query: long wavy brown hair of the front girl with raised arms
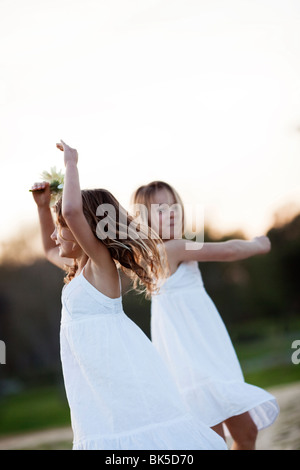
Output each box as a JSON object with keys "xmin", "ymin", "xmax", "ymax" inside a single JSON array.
[{"xmin": 54, "ymin": 189, "xmax": 167, "ymax": 297}]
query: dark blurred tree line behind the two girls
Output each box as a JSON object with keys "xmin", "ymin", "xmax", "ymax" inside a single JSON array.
[{"xmin": 0, "ymin": 214, "xmax": 300, "ymax": 395}]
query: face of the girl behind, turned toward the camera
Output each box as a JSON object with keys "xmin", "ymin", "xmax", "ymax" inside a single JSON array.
[{"xmin": 149, "ymin": 189, "xmax": 182, "ymax": 240}]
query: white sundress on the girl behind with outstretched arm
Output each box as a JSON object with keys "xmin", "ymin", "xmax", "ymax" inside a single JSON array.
[{"xmin": 151, "ymin": 261, "xmax": 279, "ymax": 433}]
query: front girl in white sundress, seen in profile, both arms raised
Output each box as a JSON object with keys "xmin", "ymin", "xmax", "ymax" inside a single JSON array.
[{"xmin": 32, "ymin": 142, "xmax": 226, "ymax": 450}]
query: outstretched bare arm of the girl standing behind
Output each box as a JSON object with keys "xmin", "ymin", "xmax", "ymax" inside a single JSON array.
[{"xmin": 165, "ymin": 236, "xmax": 271, "ymax": 265}]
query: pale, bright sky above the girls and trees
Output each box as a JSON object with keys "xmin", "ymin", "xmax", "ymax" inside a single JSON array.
[{"xmin": 0, "ymin": 0, "xmax": 300, "ymax": 252}]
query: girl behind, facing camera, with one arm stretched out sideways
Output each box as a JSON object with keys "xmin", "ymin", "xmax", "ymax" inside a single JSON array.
[{"xmin": 133, "ymin": 181, "xmax": 279, "ymax": 449}]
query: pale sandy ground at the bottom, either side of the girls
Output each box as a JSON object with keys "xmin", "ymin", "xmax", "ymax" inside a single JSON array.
[{"xmin": 0, "ymin": 382, "xmax": 300, "ymax": 450}]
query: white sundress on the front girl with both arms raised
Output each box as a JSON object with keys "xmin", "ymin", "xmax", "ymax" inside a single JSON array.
[{"xmin": 60, "ymin": 271, "xmax": 227, "ymax": 450}]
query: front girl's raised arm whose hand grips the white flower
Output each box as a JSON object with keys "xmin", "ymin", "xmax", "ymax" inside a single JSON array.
[{"xmin": 31, "ymin": 182, "xmax": 71, "ymax": 269}]
